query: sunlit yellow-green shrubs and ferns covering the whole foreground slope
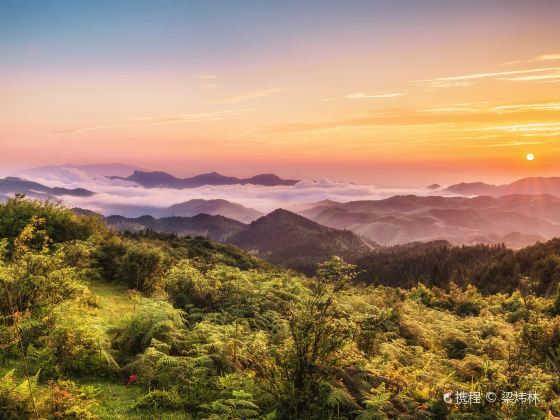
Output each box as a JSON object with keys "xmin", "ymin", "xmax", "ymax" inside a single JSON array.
[{"xmin": 0, "ymin": 197, "xmax": 560, "ymax": 420}]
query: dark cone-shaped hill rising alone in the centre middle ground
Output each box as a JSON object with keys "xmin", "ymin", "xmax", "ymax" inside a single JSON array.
[{"xmin": 228, "ymin": 209, "xmax": 377, "ymax": 273}]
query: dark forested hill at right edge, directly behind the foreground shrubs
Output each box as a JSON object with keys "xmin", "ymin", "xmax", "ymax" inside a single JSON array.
[{"xmin": 356, "ymin": 238, "xmax": 560, "ymax": 295}]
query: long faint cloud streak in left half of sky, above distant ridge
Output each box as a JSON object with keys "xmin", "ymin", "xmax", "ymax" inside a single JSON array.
[{"xmin": 55, "ymin": 109, "xmax": 246, "ymax": 134}]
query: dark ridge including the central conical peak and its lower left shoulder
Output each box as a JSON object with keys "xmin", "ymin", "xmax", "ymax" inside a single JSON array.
[{"xmin": 103, "ymin": 209, "xmax": 379, "ymax": 273}]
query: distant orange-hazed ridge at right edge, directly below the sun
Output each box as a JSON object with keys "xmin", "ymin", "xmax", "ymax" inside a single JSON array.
[{"xmin": 444, "ymin": 177, "xmax": 560, "ymax": 197}]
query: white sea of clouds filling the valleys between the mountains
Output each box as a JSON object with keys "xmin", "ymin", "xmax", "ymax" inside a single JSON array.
[{"xmin": 19, "ymin": 167, "xmax": 440, "ymax": 217}]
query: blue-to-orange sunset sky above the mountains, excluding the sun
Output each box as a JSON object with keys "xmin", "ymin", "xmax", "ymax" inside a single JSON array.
[{"xmin": 0, "ymin": 0, "xmax": 560, "ymax": 186}]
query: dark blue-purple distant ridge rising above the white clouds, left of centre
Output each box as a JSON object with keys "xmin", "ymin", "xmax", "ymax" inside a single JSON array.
[{"xmin": 109, "ymin": 170, "xmax": 299, "ymax": 189}]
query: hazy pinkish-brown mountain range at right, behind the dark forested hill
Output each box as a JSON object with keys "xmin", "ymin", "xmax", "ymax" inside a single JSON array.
[{"xmin": 299, "ymin": 194, "xmax": 560, "ymax": 248}]
